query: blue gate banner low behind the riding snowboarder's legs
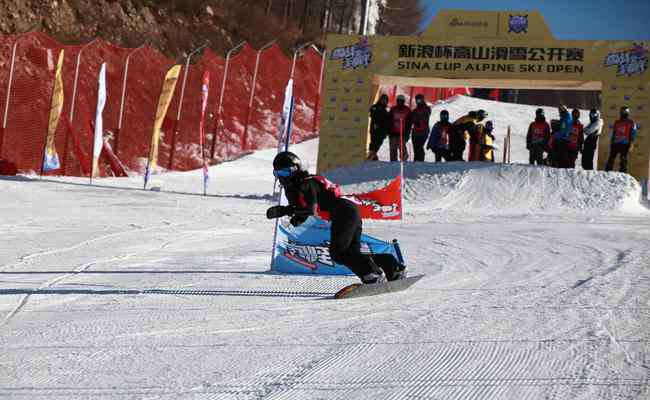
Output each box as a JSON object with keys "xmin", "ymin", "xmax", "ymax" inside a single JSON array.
[{"xmin": 271, "ymin": 217, "xmax": 397, "ymax": 275}]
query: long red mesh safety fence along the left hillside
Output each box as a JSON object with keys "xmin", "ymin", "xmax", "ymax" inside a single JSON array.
[{"xmin": 0, "ymin": 32, "xmax": 323, "ymax": 176}]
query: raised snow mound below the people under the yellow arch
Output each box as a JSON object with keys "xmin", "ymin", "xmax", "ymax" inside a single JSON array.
[{"xmin": 328, "ymin": 162, "xmax": 647, "ymax": 213}]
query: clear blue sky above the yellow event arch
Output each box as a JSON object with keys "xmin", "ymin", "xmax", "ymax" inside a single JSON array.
[{"xmin": 420, "ymin": 0, "xmax": 650, "ymax": 40}]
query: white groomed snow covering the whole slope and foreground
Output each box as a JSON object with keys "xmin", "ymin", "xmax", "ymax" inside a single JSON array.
[{"xmin": 0, "ymin": 99, "xmax": 650, "ymax": 400}]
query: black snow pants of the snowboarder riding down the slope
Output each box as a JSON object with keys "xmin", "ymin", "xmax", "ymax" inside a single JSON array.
[{"xmin": 330, "ymin": 199, "xmax": 399, "ymax": 279}]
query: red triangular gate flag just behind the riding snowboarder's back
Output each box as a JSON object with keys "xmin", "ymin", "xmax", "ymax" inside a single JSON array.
[{"xmin": 318, "ymin": 175, "xmax": 402, "ymax": 220}]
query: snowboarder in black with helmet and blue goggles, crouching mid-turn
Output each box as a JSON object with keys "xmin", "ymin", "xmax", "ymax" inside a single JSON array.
[{"xmin": 266, "ymin": 151, "xmax": 406, "ymax": 283}]
